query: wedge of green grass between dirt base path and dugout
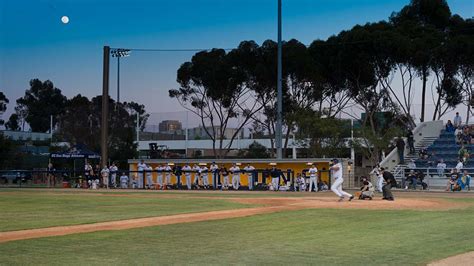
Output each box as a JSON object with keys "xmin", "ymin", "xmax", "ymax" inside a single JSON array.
[{"xmin": 0, "ymin": 193, "xmax": 255, "ymax": 231}]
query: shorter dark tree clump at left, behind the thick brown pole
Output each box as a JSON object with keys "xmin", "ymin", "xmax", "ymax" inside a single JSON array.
[{"xmin": 0, "ymin": 79, "xmax": 149, "ymax": 167}]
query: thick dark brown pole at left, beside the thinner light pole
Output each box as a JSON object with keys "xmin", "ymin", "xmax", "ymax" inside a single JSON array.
[{"xmin": 100, "ymin": 46, "xmax": 110, "ymax": 166}]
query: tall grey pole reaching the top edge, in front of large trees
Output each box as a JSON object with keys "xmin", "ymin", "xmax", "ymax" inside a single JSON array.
[{"xmin": 275, "ymin": 0, "xmax": 283, "ymax": 160}]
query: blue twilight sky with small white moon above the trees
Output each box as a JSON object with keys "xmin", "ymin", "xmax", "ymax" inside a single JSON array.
[{"xmin": 0, "ymin": 0, "xmax": 474, "ymax": 122}]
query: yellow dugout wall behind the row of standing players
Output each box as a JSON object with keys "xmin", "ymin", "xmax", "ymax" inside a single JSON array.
[{"xmin": 128, "ymin": 158, "xmax": 348, "ymax": 189}]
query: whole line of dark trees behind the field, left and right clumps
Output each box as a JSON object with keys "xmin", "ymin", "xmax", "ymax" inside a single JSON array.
[{"xmin": 0, "ymin": 0, "xmax": 474, "ymax": 165}]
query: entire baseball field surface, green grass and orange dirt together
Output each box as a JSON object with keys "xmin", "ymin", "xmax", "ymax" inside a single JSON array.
[{"xmin": 0, "ymin": 189, "xmax": 474, "ymax": 265}]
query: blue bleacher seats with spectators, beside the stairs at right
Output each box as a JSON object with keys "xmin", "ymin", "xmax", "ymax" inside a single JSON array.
[{"xmin": 415, "ymin": 129, "xmax": 474, "ymax": 169}]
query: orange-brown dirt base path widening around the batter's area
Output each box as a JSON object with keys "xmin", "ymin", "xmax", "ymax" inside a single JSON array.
[{"xmin": 0, "ymin": 192, "xmax": 468, "ymax": 243}]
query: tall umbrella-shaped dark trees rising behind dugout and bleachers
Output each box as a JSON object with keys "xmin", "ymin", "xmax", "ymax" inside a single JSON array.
[{"xmin": 169, "ymin": 0, "xmax": 474, "ymax": 161}]
